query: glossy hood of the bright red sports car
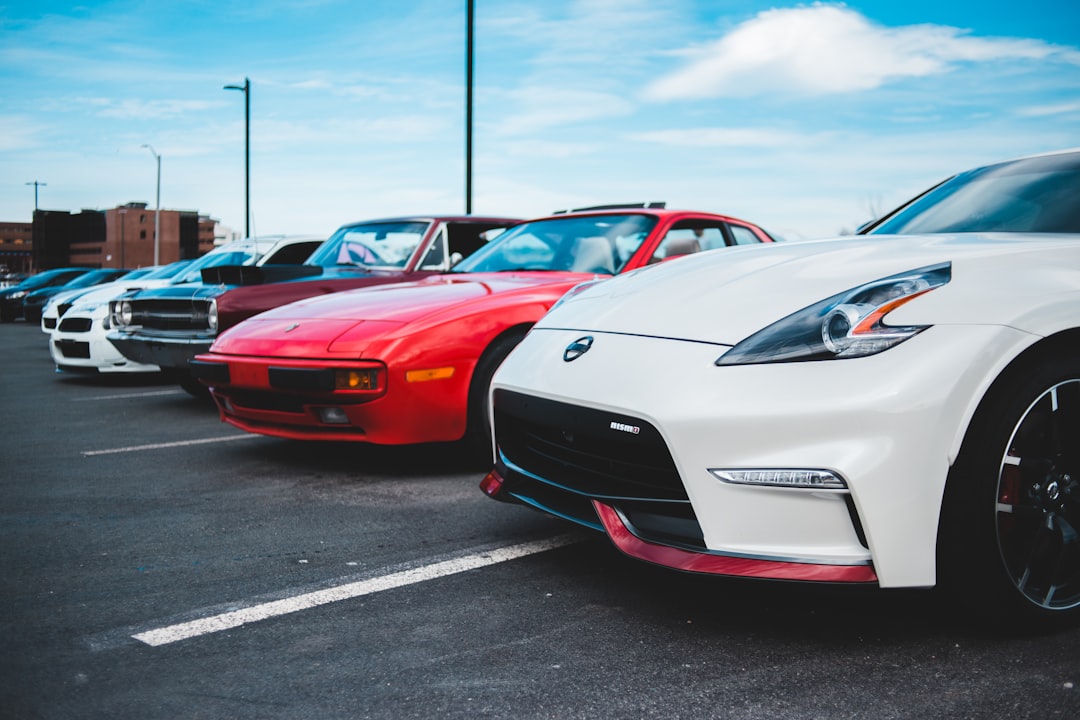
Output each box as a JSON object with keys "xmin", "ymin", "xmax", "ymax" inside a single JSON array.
[{"xmin": 211, "ymin": 272, "xmax": 594, "ymax": 358}]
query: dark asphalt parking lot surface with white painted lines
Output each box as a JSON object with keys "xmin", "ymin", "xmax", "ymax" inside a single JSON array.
[{"xmin": 0, "ymin": 323, "xmax": 1080, "ymax": 720}]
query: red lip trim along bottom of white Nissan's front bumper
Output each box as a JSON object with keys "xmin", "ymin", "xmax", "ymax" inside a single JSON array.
[{"xmin": 593, "ymin": 500, "xmax": 877, "ymax": 583}]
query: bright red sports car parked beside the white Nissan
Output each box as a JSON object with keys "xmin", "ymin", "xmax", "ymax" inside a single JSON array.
[{"xmin": 191, "ymin": 204, "xmax": 772, "ymax": 457}]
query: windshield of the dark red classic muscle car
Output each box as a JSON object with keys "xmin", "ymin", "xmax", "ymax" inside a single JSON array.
[{"xmin": 305, "ymin": 220, "xmax": 431, "ymax": 269}]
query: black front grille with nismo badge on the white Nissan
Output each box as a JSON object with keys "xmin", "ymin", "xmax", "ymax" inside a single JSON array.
[{"xmin": 494, "ymin": 390, "xmax": 689, "ymax": 501}]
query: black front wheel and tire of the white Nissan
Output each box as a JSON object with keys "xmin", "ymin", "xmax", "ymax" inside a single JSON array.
[{"xmin": 939, "ymin": 340, "xmax": 1080, "ymax": 626}]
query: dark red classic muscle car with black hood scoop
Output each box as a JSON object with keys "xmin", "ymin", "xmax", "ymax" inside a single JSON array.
[{"xmin": 110, "ymin": 215, "xmax": 519, "ymax": 396}]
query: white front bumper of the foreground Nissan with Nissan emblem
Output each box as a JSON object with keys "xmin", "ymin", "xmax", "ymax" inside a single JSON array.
[{"xmin": 487, "ymin": 326, "xmax": 1034, "ymax": 586}]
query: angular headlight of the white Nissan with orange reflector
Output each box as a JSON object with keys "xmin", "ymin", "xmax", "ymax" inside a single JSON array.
[{"xmin": 716, "ymin": 262, "xmax": 953, "ymax": 365}]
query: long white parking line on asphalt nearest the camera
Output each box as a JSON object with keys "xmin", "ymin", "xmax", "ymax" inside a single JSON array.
[{"xmin": 132, "ymin": 535, "xmax": 581, "ymax": 647}]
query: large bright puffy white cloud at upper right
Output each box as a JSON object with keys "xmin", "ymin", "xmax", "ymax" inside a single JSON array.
[{"xmin": 645, "ymin": 3, "xmax": 1080, "ymax": 100}]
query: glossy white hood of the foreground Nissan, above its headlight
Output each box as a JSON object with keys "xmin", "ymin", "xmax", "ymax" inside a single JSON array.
[{"xmin": 537, "ymin": 233, "xmax": 1080, "ymax": 344}]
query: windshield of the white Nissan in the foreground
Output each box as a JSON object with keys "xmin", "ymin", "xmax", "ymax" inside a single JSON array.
[{"xmin": 868, "ymin": 153, "xmax": 1080, "ymax": 234}]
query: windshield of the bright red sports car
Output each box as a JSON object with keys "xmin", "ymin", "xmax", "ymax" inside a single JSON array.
[{"xmin": 453, "ymin": 214, "xmax": 657, "ymax": 275}]
